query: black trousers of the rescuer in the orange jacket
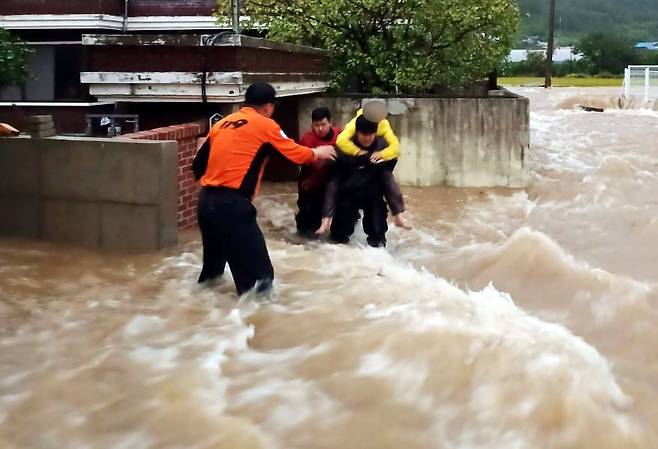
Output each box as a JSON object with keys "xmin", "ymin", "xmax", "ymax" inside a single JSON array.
[{"xmin": 197, "ymin": 187, "xmax": 274, "ymax": 295}]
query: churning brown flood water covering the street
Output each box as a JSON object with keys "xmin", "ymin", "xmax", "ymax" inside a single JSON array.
[{"xmin": 0, "ymin": 88, "xmax": 658, "ymax": 449}]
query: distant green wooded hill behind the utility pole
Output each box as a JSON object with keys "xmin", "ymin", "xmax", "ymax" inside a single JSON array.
[{"xmin": 519, "ymin": 0, "xmax": 658, "ymax": 44}]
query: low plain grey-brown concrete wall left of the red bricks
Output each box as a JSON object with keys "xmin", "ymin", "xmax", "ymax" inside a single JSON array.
[{"xmin": 0, "ymin": 137, "xmax": 178, "ymax": 251}]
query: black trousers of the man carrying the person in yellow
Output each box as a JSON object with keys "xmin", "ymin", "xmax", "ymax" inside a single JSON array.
[{"xmin": 331, "ymin": 194, "xmax": 388, "ymax": 248}]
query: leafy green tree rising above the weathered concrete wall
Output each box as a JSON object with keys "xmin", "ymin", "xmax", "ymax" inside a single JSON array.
[{"xmin": 220, "ymin": 0, "xmax": 518, "ymax": 93}]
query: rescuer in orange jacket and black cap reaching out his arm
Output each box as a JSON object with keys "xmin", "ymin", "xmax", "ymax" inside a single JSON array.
[{"xmin": 192, "ymin": 83, "xmax": 336, "ymax": 295}]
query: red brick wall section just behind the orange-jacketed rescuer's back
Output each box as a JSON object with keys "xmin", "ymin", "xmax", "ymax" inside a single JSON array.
[{"xmin": 122, "ymin": 123, "xmax": 202, "ymax": 230}]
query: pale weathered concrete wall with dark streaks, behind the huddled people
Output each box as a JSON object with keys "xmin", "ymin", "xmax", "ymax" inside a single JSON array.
[{"xmin": 299, "ymin": 91, "xmax": 530, "ymax": 187}]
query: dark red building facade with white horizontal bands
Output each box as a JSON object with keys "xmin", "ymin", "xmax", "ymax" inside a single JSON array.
[{"xmin": 0, "ymin": 0, "xmax": 328, "ymax": 136}]
